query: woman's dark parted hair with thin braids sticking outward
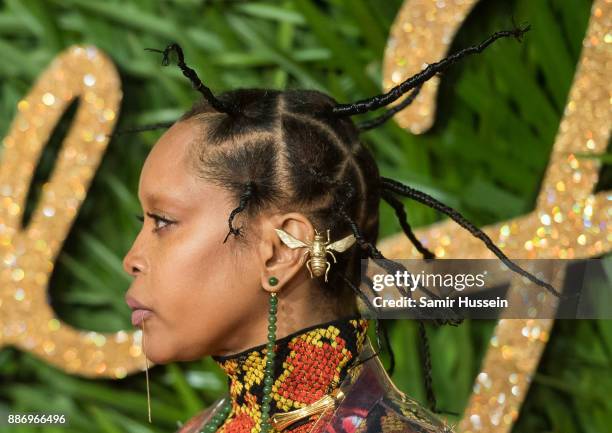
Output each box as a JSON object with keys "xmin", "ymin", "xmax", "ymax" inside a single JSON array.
[{"xmin": 113, "ymin": 25, "xmax": 560, "ymax": 413}]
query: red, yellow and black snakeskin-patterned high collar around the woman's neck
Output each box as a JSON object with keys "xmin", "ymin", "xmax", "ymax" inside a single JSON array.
[{"xmin": 212, "ymin": 315, "xmax": 368, "ymax": 432}]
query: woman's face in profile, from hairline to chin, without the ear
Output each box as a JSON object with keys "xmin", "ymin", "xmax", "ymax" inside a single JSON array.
[{"xmin": 123, "ymin": 120, "xmax": 267, "ymax": 363}]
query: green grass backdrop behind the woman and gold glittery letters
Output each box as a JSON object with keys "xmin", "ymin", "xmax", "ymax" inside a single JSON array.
[{"xmin": 0, "ymin": 0, "xmax": 612, "ymax": 433}]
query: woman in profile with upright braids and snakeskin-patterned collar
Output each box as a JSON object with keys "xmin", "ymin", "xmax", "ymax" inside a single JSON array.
[{"xmin": 124, "ymin": 24, "xmax": 560, "ymax": 433}]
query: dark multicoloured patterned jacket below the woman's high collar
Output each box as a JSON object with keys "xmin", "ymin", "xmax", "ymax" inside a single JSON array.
[{"xmin": 176, "ymin": 338, "xmax": 454, "ymax": 433}]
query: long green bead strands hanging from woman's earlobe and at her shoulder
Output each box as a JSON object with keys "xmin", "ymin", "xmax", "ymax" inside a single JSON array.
[{"xmin": 200, "ymin": 284, "xmax": 278, "ymax": 433}]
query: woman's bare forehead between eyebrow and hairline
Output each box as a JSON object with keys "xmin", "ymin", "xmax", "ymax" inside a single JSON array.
[{"xmin": 138, "ymin": 122, "xmax": 199, "ymax": 205}]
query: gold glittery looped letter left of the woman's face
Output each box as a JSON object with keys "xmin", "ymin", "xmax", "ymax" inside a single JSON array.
[{"xmin": 0, "ymin": 46, "xmax": 144, "ymax": 378}]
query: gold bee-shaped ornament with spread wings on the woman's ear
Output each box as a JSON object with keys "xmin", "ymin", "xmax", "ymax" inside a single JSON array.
[{"xmin": 274, "ymin": 229, "xmax": 356, "ymax": 282}]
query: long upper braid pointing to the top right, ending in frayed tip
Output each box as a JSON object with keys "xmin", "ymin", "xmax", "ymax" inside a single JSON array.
[{"xmin": 332, "ymin": 25, "xmax": 530, "ymax": 116}]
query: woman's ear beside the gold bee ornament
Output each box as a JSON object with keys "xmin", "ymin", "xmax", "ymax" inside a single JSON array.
[{"xmin": 258, "ymin": 212, "xmax": 314, "ymax": 292}]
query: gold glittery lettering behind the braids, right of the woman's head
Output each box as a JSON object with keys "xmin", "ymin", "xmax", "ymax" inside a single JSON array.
[{"xmin": 380, "ymin": 0, "xmax": 612, "ymax": 433}]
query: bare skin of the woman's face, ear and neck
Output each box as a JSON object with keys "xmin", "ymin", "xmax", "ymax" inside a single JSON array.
[{"xmin": 123, "ymin": 119, "xmax": 339, "ymax": 364}]
